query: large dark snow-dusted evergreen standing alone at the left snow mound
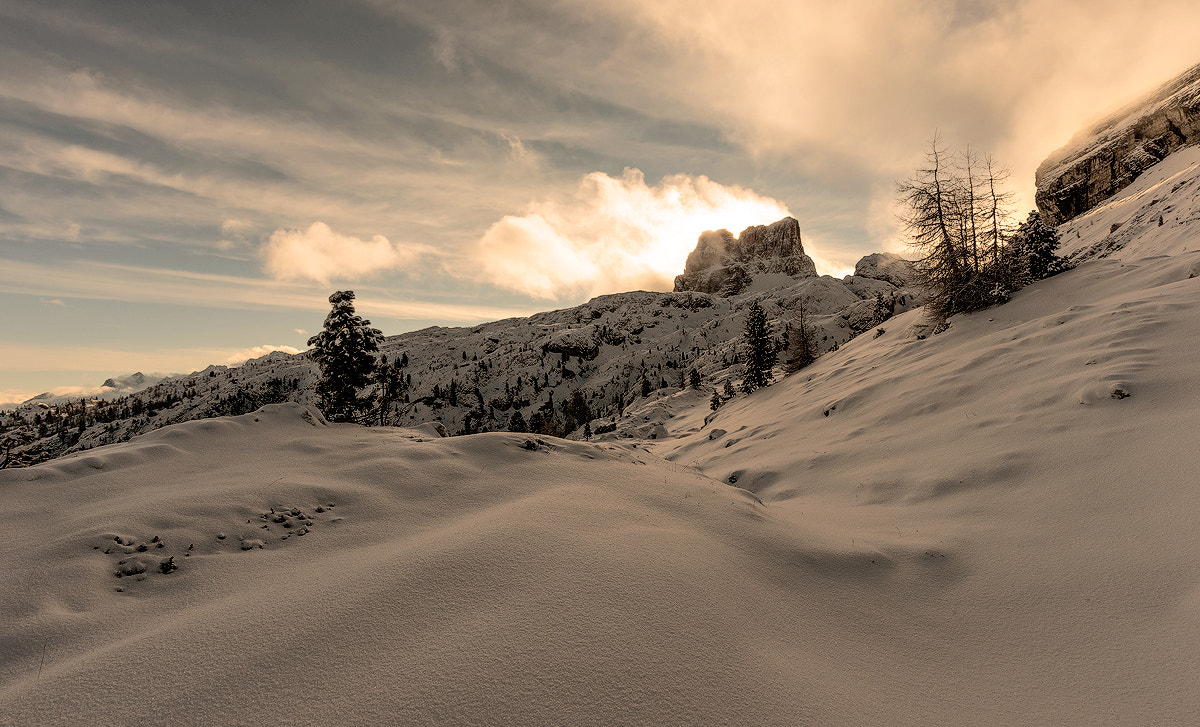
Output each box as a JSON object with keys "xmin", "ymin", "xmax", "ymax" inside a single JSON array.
[{"xmin": 308, "ymin": 290, "xmax": 383, "ymax": 421}]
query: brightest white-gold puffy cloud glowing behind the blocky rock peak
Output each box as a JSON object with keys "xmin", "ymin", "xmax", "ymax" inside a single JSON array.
[{"xmin": 474, "ymin": 168, "xmax": 790, "ymax": 299}]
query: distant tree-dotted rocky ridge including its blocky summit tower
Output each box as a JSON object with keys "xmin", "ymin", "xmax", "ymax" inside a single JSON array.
[{"xmin": 0, "ymin": 218, "xmax": 923, "ymax": 464}]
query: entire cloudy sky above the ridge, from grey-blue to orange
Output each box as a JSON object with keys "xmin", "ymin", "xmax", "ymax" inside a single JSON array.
[{"xmin": 0, "ymin": 0, "xmax": 1200, "ymax": 401}]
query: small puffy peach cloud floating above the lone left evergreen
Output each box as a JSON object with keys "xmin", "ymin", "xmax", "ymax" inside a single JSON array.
[{"xmin": 262, "ymin": 222, "xmax": 430, "ymax": 283}]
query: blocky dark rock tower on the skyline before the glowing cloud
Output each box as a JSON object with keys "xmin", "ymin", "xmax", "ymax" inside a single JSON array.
[{"xmin": 674, "ymin": 217, "xmax": 817, "ymax": 296}]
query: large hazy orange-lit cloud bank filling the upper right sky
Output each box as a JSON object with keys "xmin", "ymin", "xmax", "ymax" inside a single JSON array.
[{"xmin": 608, "ymin": 0, "xmax": 1200, "ymax": 230}]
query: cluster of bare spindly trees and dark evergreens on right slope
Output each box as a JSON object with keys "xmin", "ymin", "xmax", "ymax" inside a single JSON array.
[{"xmin": 896, "ymin": 138, "xmax": 1066, "ymax": 323}]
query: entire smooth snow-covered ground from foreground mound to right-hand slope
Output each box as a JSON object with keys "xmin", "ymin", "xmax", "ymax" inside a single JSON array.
[{"xmin": 0, "ymin": 146, "xmax": 1200, "ymax": 725}]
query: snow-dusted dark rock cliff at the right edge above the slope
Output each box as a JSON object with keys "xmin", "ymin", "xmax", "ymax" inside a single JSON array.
[{"xmin": 1036, "ymin": 65, "xmax": 1200, "ymax": 224}]
